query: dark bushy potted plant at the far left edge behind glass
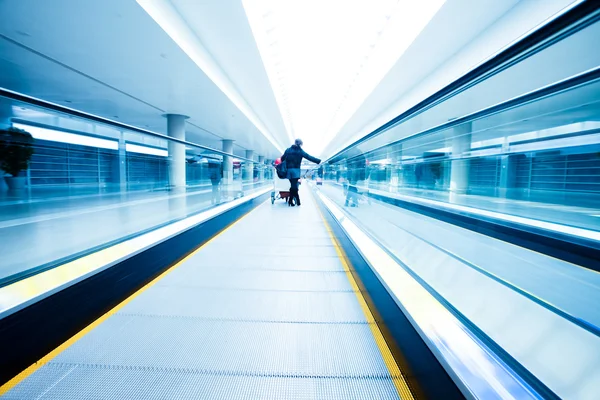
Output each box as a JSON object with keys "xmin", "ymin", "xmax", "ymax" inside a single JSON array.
[{"xmin": 0, "ymin": 127, "xmax": 33, "ymax": 189}]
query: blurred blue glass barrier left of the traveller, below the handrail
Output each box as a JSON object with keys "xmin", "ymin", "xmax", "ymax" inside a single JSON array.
[{"xmin": 0, "ymin": 97, "xmax": 272, "ymax": 285}]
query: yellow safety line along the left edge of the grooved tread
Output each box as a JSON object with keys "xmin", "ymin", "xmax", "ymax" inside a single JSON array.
[{"xmin": 0, "ymin": 208, "xmax": 255, "ymax": 396}]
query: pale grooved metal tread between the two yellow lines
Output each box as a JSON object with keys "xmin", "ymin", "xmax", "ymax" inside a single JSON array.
[{"xmin": 5, "ymin": 190, "xmax": 398, "ymax": 400}]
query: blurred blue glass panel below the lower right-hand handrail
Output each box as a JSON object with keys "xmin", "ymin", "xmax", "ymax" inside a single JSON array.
[{"xmin": 323, "ymin": 68, "xmax": 600, "ymax": 231}]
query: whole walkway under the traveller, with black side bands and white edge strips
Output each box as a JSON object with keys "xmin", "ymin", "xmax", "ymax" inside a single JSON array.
[{"xmin": 0, "ymin": 188, "xmax": 576, "ymax": 399}]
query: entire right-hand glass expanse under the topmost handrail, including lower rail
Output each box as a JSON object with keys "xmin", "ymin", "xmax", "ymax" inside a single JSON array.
[{"xmin": 321, "ymin": 6, "xmax": 600, "ymax": 236}]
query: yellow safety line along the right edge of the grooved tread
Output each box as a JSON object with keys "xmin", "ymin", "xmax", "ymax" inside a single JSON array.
[{"xmin": 315, "ymin": 196, "xmax": 415, "ymax": 400}]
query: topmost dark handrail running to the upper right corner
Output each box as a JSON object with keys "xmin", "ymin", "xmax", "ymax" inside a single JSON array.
[{"xmin": 324, "ymin": 1, "xmax": 600, "ymax": 164}]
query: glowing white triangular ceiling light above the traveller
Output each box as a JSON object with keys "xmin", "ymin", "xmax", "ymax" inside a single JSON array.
[{"xmin": 243, "ymin": 0, "xmax": 445, "ymax": 155}]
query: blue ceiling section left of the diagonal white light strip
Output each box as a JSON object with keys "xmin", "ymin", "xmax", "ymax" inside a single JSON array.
[{"xmin": 0, "ymin": 0, "xmax": 288, "ymax": 158}]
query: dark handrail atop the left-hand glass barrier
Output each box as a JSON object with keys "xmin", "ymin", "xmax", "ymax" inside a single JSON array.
[{"xmin": 0, "ymin": 87, "xmax": 258, "ymax": 163}]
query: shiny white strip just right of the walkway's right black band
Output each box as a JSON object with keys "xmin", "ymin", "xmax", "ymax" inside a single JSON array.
[{"xmin": 317, "ymin": 191, "xmax": 540, "ymax": 399}]
